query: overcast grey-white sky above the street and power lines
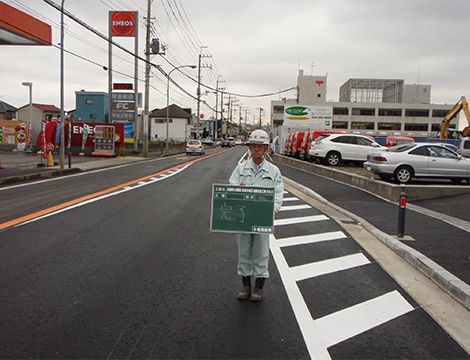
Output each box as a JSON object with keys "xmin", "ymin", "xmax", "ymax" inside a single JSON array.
[{"xmin": 0, "ymin": 0, "xmax": 470, "ymax": 124}]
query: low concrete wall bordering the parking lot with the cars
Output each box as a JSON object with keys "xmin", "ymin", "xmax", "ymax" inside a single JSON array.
[{"xmin": 270, "ymin": 154, "xmax": 470, "ymax": 202}]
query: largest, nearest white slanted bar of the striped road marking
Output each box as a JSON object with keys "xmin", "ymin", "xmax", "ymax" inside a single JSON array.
[{"xmin": 318, "ymin": 290, "xmax": 414, "ymax": 348}]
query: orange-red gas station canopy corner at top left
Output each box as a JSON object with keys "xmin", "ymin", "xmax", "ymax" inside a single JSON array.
[{"xmin": 0, "ymin": 1, "xmax": 52, "ymax": 45}]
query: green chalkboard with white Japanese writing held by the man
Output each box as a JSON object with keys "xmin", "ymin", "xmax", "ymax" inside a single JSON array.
[{"xmin": 211, "ymin": 184, "xmax": 275, "ymax": 234}]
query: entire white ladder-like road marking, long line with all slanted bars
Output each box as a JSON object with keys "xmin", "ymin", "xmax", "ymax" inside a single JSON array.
[{"xmin": 270, "ymin": 190, "xmax": 413, "ymax": 359}]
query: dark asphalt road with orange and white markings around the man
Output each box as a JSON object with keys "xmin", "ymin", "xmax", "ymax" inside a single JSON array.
[{"xmin": 0, "ymin": 148, "xmax": 470, "ymax": 359}]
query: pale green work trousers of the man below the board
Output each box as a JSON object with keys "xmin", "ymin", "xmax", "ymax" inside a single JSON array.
[{"xmin": 236, "ymin": 233, "xmax": 269, "ymax": 278}]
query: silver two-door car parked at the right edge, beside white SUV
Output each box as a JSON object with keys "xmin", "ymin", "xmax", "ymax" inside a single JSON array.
[{"xmin": 364, "ymin": 143, "xmax": 470, "ymax": 184}]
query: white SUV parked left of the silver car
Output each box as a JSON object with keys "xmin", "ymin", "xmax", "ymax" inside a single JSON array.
[{"xmin": 309, "ymin": 134, "xmax": 381, "ymax": 166}]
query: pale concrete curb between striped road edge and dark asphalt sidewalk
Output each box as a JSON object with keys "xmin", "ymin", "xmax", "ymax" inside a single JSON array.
[{"xmin": 283, "ymin": 177, "xmax": 470, "ymax": 310}]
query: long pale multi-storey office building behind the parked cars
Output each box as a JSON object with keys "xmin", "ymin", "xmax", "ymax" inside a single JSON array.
[{"xmin": 271, "ymin": 70, "xmax": 458, "ymax": 138}]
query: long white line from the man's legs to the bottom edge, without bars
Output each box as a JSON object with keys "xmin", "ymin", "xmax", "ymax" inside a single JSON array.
[{"xmin": 269, "ymin": 235, "xmax": 331, "ymax": 360}]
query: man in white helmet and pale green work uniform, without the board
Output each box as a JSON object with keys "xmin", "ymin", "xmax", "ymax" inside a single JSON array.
[{"xmin": 229, "ymin": 130, "xmax": 284, "ymax": 301}]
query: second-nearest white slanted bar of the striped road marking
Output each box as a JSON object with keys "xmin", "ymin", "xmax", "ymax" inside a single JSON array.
[{"xmin": 290, "ymin": 253, "xmax": 370, "ymax": 281}]
